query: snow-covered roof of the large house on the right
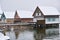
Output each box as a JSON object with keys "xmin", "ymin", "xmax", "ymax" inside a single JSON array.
[{"xmin": 32, "ymin": 6, "xmax": 59, "ymax": 15}]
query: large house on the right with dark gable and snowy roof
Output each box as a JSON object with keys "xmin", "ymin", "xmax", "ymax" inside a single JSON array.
[{"xmin": 33, "ymin": 6, "xmax": 59, "ymax": 28}]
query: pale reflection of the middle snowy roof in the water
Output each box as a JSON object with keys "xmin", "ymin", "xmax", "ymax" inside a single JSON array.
[{"xmin": 17, "ymin": 30, "xmax": 34, "ymax": 40}]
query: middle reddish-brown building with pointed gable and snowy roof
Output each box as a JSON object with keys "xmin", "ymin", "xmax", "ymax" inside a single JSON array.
[{"xmin": 14, "ymin": 10, "xmax": 33, "ymax": 23}]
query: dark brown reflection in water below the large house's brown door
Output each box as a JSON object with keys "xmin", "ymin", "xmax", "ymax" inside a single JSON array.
[{"xmin": 34, "ymin": 28, "xmax": 45, "ymax": 40}]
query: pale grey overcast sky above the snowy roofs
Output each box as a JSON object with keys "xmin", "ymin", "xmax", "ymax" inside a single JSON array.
[{"xmin": 0, "ymin": 0, "xmax": 60, "ymax": 11}]
